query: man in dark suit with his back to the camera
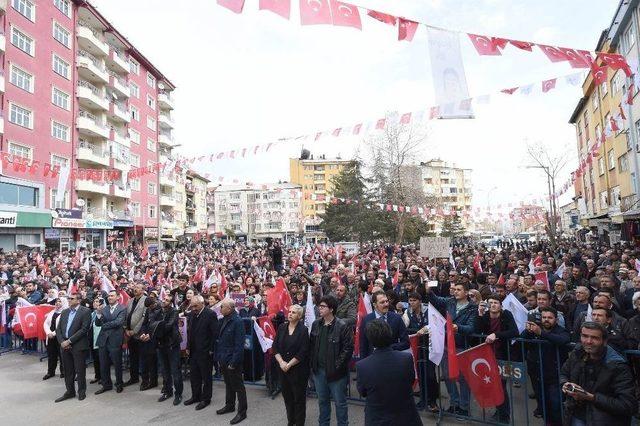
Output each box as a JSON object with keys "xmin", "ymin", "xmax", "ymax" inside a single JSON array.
[{"xmin": 356, "ymin": 319, "xmax": 422, "ymax": 426}]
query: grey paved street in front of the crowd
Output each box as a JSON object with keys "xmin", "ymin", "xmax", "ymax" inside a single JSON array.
[{"xmin": 0, "ymin": 353, "xmax": 450, "ymax": 426}]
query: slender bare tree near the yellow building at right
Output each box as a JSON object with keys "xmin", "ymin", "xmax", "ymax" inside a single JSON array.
[{"xmin": 527, "ymin": 142, "xmax": 569, "ymax": 246}]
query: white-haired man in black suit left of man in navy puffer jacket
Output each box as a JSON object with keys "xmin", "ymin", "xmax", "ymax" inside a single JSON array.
[{"xmin": 184, "ymin": 295, "xmax": 218, "ymax": 410}]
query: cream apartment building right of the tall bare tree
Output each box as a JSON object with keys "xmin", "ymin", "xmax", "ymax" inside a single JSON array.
[{"xmin": 419, "ymin": 159, "xmax": 473, "ymax": 232}]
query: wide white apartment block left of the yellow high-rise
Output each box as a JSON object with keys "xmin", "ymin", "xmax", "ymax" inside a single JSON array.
[{"xmin": 209, "ymin": 183, "xmax": 302, "ymax": 241}]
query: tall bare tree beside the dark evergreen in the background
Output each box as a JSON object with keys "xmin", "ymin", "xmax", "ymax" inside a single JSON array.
[{"xmin": 365, "ymin": 113, "xmax": 428, "ymax": 242}]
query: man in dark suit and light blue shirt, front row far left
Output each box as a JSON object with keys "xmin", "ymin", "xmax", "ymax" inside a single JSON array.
[{"xmin": 56, "ymin": 294, "xmax": 91, "ymax": 402}]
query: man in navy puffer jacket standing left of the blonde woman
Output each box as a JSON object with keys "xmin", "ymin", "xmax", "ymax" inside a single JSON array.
[{"xmin": 216, "ymin": 299, "xmax": 247, "ymax": 425}]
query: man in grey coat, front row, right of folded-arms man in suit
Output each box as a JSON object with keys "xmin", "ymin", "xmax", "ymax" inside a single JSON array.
[{"xmin": 124, "ymin": 282, "xmax": 149, "ymax": 390}]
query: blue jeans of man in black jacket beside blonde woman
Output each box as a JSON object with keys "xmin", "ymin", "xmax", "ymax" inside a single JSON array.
[{"xmin": 313, "ymin": 368, "xmax": 349, "ymax": 426}]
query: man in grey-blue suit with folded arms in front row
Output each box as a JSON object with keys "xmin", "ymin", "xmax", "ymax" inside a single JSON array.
[{"xmin": 96, "ymin": 290, "xmax": 127, "ymax": 395}]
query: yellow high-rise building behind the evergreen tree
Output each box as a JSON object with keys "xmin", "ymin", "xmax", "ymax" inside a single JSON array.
[{"xmin": 289, "ymin": 152, "xmax": 351, "ymax": 240}]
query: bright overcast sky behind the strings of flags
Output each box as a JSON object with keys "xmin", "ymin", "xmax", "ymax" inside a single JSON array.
[{"xmin": 92, "ymin": 0, "xmax": 618, "ymax": 213}]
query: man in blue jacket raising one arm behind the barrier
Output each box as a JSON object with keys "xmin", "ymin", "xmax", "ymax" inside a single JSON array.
[{"xmin": 426, "ymin": 282, "xmax": 478, "ymax": 416}]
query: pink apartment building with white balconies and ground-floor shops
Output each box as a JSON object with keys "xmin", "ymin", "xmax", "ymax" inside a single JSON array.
[{"xmin": 0, "ymin": 0, "xmax": 175, "ymax": 250}]
